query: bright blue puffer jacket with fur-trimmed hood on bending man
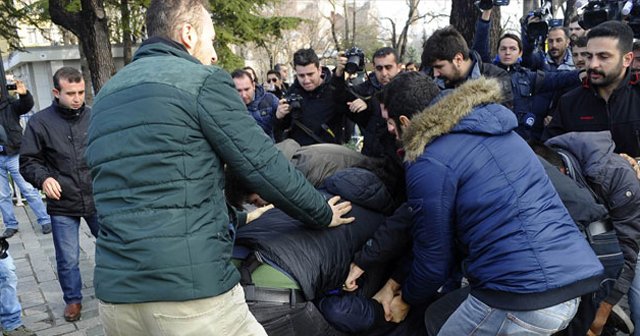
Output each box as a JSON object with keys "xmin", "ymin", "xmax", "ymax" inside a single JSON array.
[{"xmin": 403, "ymin": 78, "xmax": 603, "ymax": 310}]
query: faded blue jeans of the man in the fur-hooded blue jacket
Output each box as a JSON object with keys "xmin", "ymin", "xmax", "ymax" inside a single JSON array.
[{"xmin": 438, "ymin": 295, "xmax": 580, "ymax": 336}]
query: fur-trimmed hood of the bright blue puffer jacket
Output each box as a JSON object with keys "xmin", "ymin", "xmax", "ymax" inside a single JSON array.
[{"xmin": 402, "ymin": 77, "xmax": 518, "ymax": 162}]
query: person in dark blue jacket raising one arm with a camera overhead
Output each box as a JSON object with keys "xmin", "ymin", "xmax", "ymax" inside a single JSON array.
[{"xmin": 473, "ymin": 9, "xmax": 580, "ymax": 140}]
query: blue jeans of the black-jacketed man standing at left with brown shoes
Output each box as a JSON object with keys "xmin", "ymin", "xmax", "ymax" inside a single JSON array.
[{"xmin": 51, "ymin": 214, "xmax": 99, "ymax": 304}]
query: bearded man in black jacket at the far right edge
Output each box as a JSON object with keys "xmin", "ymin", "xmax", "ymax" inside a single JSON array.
[{"xmin": 544, "ymin": 21, "xmax": 640, "ymax": 157}]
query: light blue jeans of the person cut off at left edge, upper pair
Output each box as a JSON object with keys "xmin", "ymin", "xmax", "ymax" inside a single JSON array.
[{"xmin": 0, "ymin": 155, "xmax": 51, "ymax": 229}]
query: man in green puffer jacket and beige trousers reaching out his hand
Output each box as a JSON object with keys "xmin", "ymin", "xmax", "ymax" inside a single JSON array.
[{"xmin": 86, "ymin": 0, "xmax": 353, "ymax": 335}]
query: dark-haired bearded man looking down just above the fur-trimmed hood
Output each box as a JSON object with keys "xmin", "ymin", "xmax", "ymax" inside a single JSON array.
[{"xmin": 422, "ymin": 26, "xmax": 513, "ymax": 106}]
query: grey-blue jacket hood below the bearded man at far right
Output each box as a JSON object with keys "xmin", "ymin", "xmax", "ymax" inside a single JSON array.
[{"xmin": 546, "ymin": 131, "xmax": 615, "ymax": 175}]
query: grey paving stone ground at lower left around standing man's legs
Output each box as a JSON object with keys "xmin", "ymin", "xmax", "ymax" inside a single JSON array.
[{"xmin": 0, "ymin": 204, "xmax": 104, "ymax": 336}]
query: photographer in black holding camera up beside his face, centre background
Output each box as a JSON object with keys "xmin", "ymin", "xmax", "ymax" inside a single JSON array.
[{"xmin": 334, "ymin": 47, "xmax": 400, "ymax": 159}]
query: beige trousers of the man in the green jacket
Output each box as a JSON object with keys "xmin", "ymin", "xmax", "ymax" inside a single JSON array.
[{"xmin": 100, "ymin": 284, "xmax": 267, "ymax": 336}]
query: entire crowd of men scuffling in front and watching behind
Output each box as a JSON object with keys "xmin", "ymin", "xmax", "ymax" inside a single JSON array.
[{"xmin": 0, "ymin": 0, "xmax": 640, "ymax": 335}]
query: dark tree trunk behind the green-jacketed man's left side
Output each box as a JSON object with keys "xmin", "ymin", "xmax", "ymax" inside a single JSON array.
[{"xmin": 49, "ymin": 0, "xmax": 115, "ymax": 93}]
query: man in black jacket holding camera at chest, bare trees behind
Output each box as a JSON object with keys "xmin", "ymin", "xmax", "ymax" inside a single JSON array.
[{"xmin": 276, "ymin": 49, "xmax": 347, "ymax": 146}]
